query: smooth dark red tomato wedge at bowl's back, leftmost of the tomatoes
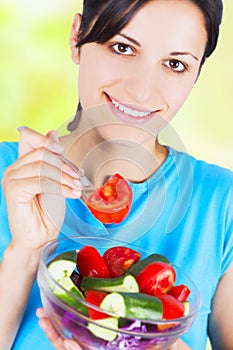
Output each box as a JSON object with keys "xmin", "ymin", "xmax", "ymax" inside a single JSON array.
[{"xmin": 76, "ymin": 245, "xmax": 110, "ymax": 278}]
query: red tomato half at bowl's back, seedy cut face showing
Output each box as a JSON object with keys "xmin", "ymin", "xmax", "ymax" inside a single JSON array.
[{"xmin": 103, "ymin": 247, "xmax": 141, "ymax": 277}]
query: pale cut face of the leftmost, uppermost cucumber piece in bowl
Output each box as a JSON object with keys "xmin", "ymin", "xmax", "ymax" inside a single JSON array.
[{"xmin": 48, "ymin": 259, "xmax": 76, "ymax": 281}]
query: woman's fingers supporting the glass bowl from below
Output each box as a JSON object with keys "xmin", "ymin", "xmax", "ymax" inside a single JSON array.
[{"xmin": 36, "ymin": 308, "xmax": 82, "ymax": 350}]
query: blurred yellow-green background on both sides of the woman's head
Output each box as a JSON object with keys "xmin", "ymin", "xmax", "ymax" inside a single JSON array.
[{"xmin": 0, "ymin": 0, "xmax": 233, "ymax": 169}]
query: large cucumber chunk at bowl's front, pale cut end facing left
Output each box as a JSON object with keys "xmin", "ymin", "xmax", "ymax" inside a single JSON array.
[{"xmin": 100, "ymin": 292, "xmax": 163, "ymax": 320}]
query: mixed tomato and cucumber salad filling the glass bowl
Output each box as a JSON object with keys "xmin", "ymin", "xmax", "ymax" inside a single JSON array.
[{"xmin": 48, "ymin": 245, "xmax": 190, "ymax": 348}]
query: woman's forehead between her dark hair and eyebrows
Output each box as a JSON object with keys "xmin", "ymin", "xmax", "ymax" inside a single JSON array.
[{"xmin": 121, "ymin": 0, "xmax": 207, "ymax": 54}]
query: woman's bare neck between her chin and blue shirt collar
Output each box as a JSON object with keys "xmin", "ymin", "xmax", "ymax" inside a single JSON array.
[{"xmin": 60, "ymin": 125, "xmax": 168, "ymax": 187}]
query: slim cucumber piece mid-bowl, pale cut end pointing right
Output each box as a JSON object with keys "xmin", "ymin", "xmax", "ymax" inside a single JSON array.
[{"xmin": 81, "ymin": 275, "xmax": 139, "ymax": 293}]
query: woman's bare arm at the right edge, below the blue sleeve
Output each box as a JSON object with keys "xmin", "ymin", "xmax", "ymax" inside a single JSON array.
[{"xmin": 209, "ymin": 263, "xmax": 233, "ymax": 350}]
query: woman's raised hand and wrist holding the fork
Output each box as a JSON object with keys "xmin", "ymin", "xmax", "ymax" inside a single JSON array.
[{"xmin": 3, "ymin": 128, "xmax": 81, "ymax": 253}]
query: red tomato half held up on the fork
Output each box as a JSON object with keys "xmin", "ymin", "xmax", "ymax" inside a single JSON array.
[{"xmin": 86, "ymin": 174, "xmax": 133, "ymax": 224}]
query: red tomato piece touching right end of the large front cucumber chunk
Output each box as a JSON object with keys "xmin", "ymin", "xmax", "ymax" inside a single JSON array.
[{"xmin": 156, "ymin": 294, "xmax": 184, "ymax": 320}]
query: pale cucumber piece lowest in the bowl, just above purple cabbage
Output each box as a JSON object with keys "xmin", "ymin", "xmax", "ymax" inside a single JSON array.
[{"xmin": 87, "ymin": 317, "xmax": 118, "ymax": 341}]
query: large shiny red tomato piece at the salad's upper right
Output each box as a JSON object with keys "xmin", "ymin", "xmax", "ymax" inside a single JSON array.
[{"xmin": 136, "ymin": 261, "xmax": 176, "ymax": 296}]
